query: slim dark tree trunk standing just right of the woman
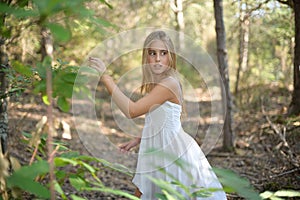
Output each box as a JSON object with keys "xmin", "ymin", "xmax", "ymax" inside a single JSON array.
[{"xmin": 214, "ymin": 0, "xmax": 234, "ymax": 151}]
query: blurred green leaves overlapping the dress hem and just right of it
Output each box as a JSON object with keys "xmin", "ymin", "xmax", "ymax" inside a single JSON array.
[{"xmin": 148, "ymin": 156, "xmax": 260, "ymax": 200}]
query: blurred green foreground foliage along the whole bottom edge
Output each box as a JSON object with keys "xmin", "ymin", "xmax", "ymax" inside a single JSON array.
[{"xmin": 2, "ymin": 131, "xmax": 299, "ymax": 200}]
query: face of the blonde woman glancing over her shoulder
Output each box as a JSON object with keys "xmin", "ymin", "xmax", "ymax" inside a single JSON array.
[{"xmin": 147, "ymin": 40, "xmax": 170, "ymax": 75}]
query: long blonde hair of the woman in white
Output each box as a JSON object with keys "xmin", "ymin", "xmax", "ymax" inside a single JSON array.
[{"xmin": 141, "ymin": 30, "xmax": 176, "ymax": 93}]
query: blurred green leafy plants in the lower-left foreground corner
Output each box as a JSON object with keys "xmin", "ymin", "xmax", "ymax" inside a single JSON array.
[{"xmin": 2, "ymin": 133, "xmax": 138, "ymax": 200}]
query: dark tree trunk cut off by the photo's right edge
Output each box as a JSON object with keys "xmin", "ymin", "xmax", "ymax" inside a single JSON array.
[{"xmin": 288, "ymin": 0, "xmax": 300, "ymax": 115}]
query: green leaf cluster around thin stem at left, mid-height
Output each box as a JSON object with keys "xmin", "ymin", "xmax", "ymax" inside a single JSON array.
[{"xmin": 2, "ymin": 57, "xmax": 90, "ymax": 112}]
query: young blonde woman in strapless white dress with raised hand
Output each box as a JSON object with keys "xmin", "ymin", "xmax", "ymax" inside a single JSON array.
[{"xmin": 89, "ymin": 30, "xmax": 226, "ymax": 200}]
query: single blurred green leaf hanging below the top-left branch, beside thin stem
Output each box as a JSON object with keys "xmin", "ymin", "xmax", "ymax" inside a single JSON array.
[{"xmin": 46, "ymin": 23, "xmax": 71, "ymax": 42}]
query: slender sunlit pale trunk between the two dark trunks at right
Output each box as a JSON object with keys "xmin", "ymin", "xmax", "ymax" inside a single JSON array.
[{"xmin": 234, "ymin": 1, "xmax": 250, "ymax": 95}]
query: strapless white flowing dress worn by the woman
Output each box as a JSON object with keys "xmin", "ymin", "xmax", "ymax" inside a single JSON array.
[{"xmin": 132, "ymin": 101, "xmax": 226, "ymax": 200}]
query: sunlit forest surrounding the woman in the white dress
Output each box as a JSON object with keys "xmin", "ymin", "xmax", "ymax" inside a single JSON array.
[{"xmin": 0, "ymin": 0, "xmax": 300, "ymax": 200}]
